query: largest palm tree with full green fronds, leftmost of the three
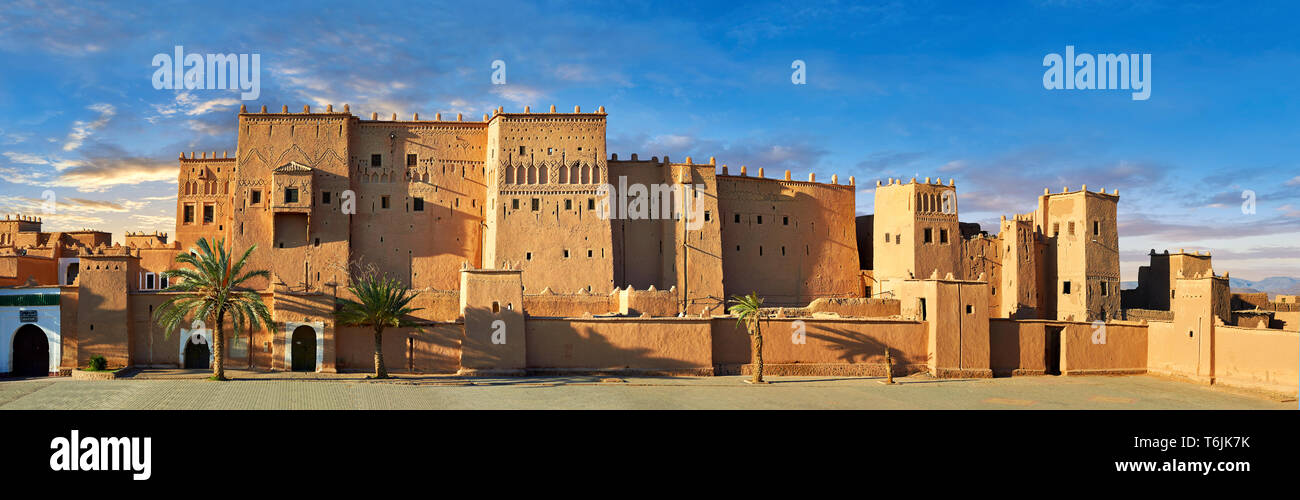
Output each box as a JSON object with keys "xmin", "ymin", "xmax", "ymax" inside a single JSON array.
[{"xmin": 153, "ymin": 238, "xmax": 276, "ymax": 381}]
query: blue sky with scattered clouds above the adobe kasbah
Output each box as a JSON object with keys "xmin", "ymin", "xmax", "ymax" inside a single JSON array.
[{"xmin": 0, "ymin": 1, "xmax": 1300, "ymax": 279}]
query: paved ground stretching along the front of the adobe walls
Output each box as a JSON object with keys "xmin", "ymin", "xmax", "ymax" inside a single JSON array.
[{"xmin": 0, "ymin": 370, "xmax": 1296, "ymax": 409}]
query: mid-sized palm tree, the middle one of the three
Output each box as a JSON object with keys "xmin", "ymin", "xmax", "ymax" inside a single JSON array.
[{"xmin": 334, "ymin": 268, "xmax": 421, "ymax": 378}]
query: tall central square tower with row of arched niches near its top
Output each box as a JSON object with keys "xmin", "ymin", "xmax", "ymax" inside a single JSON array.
[{"xmin": 484, "ymin": 106, "xmax": 614, "ymax": 294}]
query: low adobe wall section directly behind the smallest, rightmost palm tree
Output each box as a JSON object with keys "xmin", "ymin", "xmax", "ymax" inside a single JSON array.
[{"xmin": 712, "ymin": 317, "xmax": 928, "ymax": 377}]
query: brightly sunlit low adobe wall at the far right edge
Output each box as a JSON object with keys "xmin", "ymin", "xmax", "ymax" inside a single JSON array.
[{"xmin": 1214, "ymin": 326, "xmax": 1300, "ymax": 395}]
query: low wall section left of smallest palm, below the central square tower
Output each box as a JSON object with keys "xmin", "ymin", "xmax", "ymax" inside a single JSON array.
[{"xmin": 525, "ymin": 318, "xmax": 714, "ymax": 375}]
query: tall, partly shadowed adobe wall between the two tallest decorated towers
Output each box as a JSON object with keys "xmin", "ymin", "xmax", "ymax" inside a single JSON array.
[{"xmin": 348, "ymin": 119, "xmax": 488, "ymax": 290}]
